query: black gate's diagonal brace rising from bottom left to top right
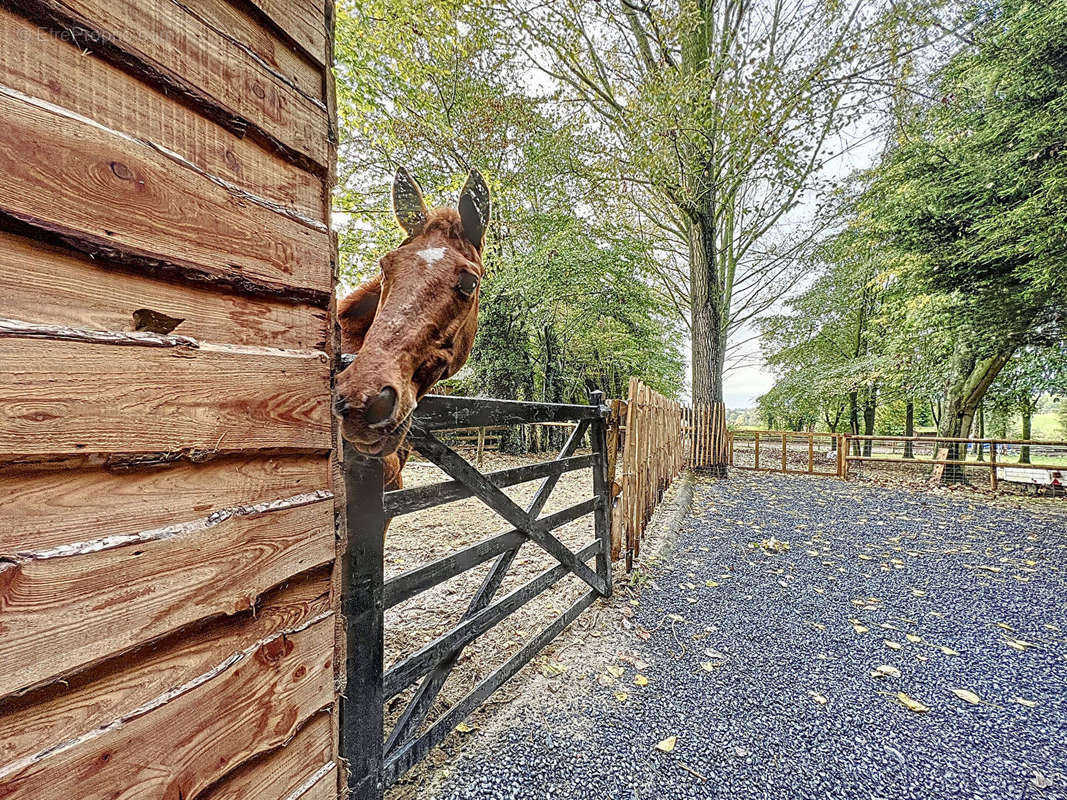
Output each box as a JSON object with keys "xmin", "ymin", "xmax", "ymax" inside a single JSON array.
[{"xmin": 384, "ymin": 419, "xmax": 589, "ymax": 757}]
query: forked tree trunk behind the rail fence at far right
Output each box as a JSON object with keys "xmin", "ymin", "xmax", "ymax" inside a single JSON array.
[{"xmin": 934, "ymin": 347, "xmax": 1015, "ymax": 483}]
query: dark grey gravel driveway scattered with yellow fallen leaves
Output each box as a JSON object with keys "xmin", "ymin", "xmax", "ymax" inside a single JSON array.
[{"xmin": 425, "ymin": 471, "xmax": 1067, "ymax": 800}]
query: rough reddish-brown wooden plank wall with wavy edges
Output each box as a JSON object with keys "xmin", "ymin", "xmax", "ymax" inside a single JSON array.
[{"xmin": 0, "ymin": 0, "xmax": 341, "ymax": 800}]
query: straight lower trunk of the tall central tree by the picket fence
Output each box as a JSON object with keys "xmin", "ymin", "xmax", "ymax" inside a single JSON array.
[{"xmin": 688, "ymin": 213, "xmax": 727, "ymax": 478}]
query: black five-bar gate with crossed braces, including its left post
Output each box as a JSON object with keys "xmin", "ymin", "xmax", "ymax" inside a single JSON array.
[{"xmin": 340, "ymin": 391, "xmax": 611, "ymax": 800}]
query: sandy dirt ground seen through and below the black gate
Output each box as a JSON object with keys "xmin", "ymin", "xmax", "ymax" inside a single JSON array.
[{"xmin": 385, "ymin": 450, "xmax": 673, "ymax": 800}]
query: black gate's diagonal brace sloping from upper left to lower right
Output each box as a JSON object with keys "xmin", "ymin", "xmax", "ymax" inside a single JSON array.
[{"xmin": 408, "ymin": 426, "xmax": 609, "ymax": 596}]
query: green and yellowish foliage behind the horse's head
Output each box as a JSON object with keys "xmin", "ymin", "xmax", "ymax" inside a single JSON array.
[{"xmin": 335, "ymin": 0, "xmax": 684, "ymax": 402}]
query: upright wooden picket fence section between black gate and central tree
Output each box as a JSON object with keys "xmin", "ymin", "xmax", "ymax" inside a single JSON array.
[{"xmin": 609, "ymin": 378, "xmax": 685, "ymax": 571}]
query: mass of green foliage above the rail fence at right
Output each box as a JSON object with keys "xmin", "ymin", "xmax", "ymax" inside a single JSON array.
[{"xmin": 764, "ymin": 0, "xmax": 1067, "ymax": 445}]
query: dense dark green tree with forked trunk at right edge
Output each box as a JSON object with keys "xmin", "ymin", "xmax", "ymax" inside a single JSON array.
[{"xmin": 869, "ymin": 0, "xmax": 1067, "ymax": 480}]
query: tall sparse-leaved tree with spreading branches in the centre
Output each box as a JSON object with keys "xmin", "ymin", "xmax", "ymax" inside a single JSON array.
[{"xmin": 504, "ymin": 0, "xmax": 930, "ymax": 466}]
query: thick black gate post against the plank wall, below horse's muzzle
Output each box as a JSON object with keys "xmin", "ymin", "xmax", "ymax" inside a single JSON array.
[{"xmin": 340, "ymin": 442, "xmax": 385, "ymax": 800}]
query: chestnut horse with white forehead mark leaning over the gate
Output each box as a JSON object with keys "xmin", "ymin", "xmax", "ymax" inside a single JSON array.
[{"xmin": 334, "ymin": 167, "xmax": 491, "ymax": 491}]
